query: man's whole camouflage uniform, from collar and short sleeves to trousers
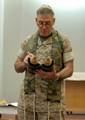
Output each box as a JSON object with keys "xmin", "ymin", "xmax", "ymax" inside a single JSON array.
[{"xmin": 18, "ymin": 30, "xmax": 73, "ymax": 120}]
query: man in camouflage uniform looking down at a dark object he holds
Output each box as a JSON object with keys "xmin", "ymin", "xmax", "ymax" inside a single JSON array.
[{"xmin": 15, "ymin": 5, "xmax": 73, "ymax": 120}]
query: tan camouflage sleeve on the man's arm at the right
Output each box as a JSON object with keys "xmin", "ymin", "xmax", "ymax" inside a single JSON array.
[{"xmin": 63, "ymin": 37, "xmax": 74, "ymax": 63}]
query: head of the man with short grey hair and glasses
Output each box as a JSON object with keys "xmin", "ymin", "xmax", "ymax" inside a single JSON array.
[{"xmin": 36, "ymin": 5, "xmax": 55, "ymax": 37}]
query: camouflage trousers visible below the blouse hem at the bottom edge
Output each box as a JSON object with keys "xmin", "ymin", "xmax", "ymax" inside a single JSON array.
[{"xmin": 18, "ymin": 109, "xmax": 64, "ymax": 120}]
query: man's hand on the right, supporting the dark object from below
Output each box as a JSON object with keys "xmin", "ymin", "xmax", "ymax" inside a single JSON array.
[{"xmin": 36, "ymin": 70, "xmax": 60, "ymax": 80}]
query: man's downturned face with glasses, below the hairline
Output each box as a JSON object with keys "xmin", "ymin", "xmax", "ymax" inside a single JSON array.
[{"xmin": 36, "ymin": 14, "xmax": 55, "ymax": 37}]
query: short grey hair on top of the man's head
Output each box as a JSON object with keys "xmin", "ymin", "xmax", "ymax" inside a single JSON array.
[{"xmin": 37, "ymin": 4, "xmax": 54, "ymax": 16}]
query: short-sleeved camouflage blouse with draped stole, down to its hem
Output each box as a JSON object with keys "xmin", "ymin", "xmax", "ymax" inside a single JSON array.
[{"xmin": 18, "ymin": 30, "xmax": 73, "ymax": 112}]
